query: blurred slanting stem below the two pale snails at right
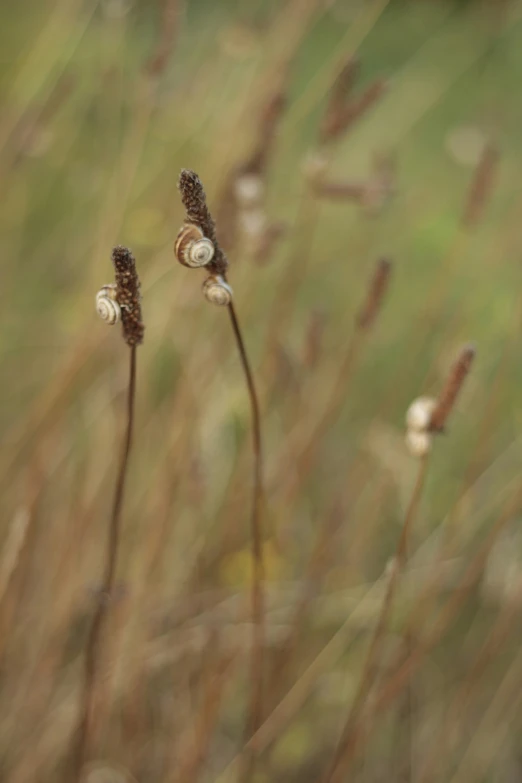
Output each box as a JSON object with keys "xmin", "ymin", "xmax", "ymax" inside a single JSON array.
[{"xmin": 323, "ymin": 457, "xmax": 428, "ymax": 783}]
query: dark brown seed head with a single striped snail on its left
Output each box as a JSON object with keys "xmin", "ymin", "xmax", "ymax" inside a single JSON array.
[{"xmin": 112, "ymin": 245, "xmax": 145, "ymax": 345}]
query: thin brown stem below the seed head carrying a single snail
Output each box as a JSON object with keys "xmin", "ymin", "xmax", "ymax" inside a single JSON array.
[{"xmin": 73, "ymin": 345, "xmax": 136, "ymax": 781}]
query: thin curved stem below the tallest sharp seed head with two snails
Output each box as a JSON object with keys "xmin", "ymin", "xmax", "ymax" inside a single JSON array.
[{"xmin": 228, "ymin": 302, "xmax": 265, "ymax": 779}]
